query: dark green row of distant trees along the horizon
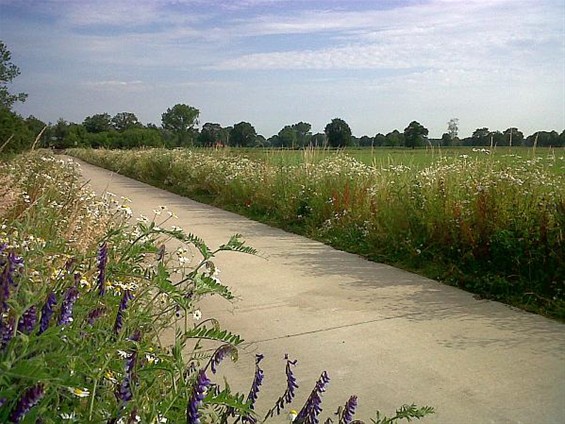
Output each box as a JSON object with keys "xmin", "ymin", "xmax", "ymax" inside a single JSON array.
[{"xmin": 0, "ymin": 41, "xmax": 565, "ymax": 152}]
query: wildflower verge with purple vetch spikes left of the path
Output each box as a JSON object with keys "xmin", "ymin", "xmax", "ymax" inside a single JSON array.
[{"xmin": 0, "ymin": 152, "xmax": 433, "ymax": 424}]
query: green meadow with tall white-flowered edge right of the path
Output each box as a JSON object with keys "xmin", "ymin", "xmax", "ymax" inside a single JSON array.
[{"xmin": 70, "ymin": 147, "xmax": 565, "ymax": 320}]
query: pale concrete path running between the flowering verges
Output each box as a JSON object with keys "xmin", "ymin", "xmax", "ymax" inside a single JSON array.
[{"xmin": 75, "ymin": 157, "xmax": 565, "ymax": 424}]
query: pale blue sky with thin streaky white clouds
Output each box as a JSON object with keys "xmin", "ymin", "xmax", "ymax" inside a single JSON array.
[{"xmin": 0, "ymin": 0, "xmax": 565, "ymax": 137}]
